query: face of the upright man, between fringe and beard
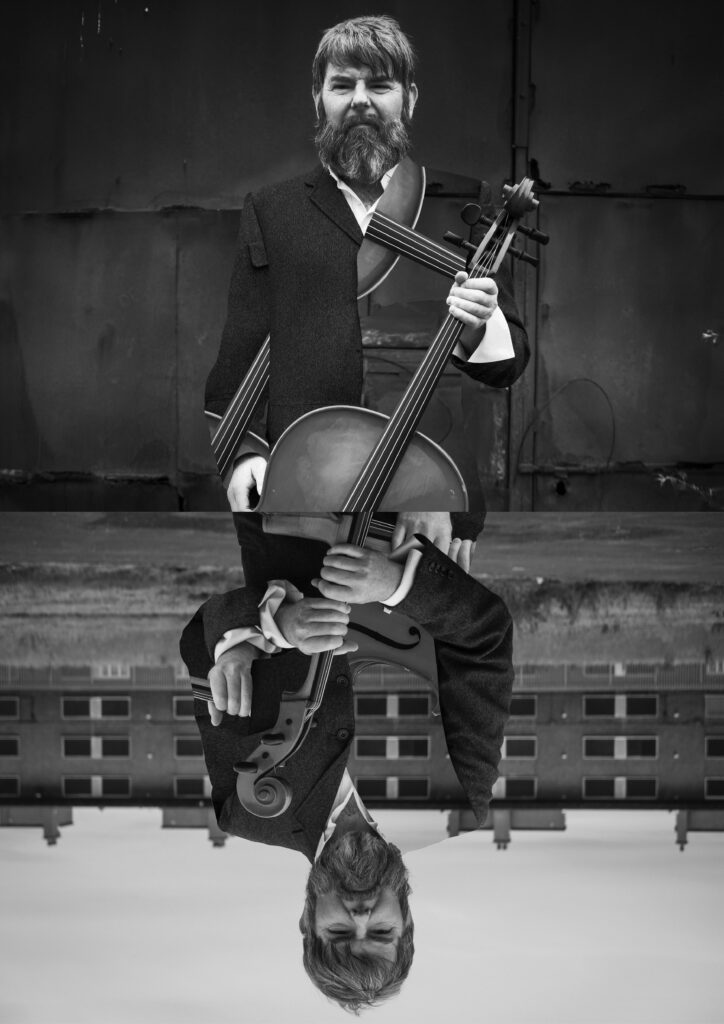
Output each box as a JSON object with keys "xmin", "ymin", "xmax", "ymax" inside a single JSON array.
[{"xmin": 314, "ymin": 63, "xmax": 417, "ymax": 128}]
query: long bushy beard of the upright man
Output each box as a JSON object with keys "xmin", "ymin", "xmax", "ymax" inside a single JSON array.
[{"xmin": 314, "ymin": 114, "xmax": 410, "ymax": 185}]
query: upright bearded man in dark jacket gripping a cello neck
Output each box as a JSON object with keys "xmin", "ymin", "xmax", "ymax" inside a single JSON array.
[{"xmin": 206, "ymin": 16, "xmax": 528, "ymax": 550}]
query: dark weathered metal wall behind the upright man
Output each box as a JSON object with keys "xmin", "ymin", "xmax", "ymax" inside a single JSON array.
[{"xmin": 0, "ymin": 0, "xmax": 724, "ymax": 509}]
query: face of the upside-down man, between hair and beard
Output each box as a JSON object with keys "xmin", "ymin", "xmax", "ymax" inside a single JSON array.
[{"xmin": 314, "ymin": 886, "xmax": 404, "ymax": 962}]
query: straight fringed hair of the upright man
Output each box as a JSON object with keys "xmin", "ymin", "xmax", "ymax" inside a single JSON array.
[{"xmin": 311, "ymin": 14, "xmax": 415, "ymax": 96}]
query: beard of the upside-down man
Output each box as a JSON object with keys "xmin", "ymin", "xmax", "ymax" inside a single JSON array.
[{"xmin": 306, "ymin": 830, "xmax": 409, "ymax": 903}]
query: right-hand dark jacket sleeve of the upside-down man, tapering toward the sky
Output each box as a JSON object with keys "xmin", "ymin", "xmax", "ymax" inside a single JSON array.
[{"xmin": 398, "ymin": 538, "xmax": 513, "ymax": 824}]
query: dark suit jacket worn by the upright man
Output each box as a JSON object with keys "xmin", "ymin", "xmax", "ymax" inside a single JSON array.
[{"xmin": 206, "ymin": 166, "xmax": 528, "ymax": 444}]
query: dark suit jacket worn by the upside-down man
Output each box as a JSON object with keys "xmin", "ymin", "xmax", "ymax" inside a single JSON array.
[{"xmin": 181, "ymin": 539, "xmax": 513, "ymax": 860}]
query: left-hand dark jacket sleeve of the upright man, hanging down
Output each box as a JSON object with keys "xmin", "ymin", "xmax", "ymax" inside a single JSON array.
[{"xmin": 206, "ymin": 195, "xmax": 269, "ymax": 437}]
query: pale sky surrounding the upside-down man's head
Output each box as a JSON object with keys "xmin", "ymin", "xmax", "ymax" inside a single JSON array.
[{"xmin": 0, "ymin": 808, "xmax": 724, "ymax": 1024}]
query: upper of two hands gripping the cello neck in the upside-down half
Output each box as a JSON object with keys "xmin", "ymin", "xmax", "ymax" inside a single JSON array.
[{"xmin": 311, "ymin": 544, "xmax": 402, "ymax": 604}]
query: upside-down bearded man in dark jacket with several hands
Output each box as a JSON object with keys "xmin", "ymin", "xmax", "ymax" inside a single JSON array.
[{"xmin": 181, "ymin": 535, "xmax": 513, "ymax": 1010}]
